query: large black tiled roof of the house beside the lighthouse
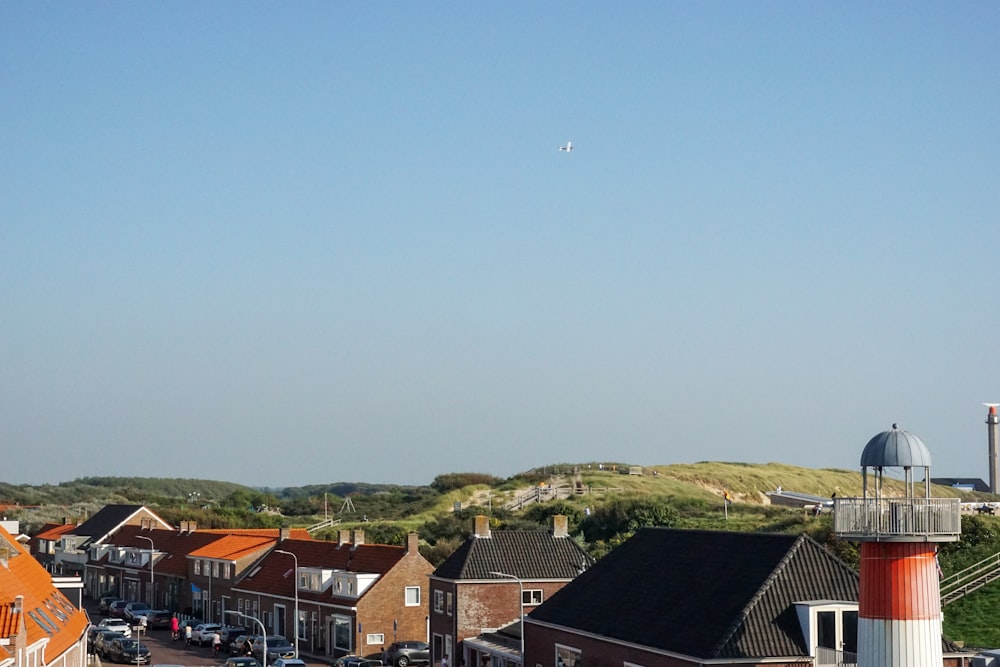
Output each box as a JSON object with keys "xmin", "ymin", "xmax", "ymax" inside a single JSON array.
[{"xmin": 529, "ymin": 528, "xmax": 859, "ymax": 659}]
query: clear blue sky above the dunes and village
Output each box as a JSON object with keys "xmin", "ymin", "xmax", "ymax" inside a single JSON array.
[{"xmin": 0, "ymin": 0, "xmax": 1000, "ymax": 487}]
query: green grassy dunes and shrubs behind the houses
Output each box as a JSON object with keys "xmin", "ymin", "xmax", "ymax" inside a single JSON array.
[{"xmin": 0, "ymin": 461, "xmax": 1000, "ymax": 646}]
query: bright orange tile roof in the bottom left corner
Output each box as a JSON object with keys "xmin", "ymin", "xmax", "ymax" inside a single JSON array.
[{"xmin": 0, "ymin": 527, "xmax": 88, "ymax": 664}]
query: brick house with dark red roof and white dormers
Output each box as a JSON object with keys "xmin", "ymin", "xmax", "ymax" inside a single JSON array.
[{"xmin": 230, "ymin": 530, "xmax": 434, "ymax": 658}]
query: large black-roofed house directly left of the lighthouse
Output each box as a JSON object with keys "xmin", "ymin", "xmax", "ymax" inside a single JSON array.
[{"xmin": 525, "ymin": 528, "xmax": 968, "ymax": 667}]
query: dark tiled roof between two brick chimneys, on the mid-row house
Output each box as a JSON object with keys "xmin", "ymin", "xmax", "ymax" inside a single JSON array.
[{"xmin": 434, "ymin": 530, "xmax": 594, "ymax": 580}]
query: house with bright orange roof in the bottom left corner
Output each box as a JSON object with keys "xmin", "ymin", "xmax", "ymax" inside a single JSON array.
[{"xmin": 0, "ymin": 527, "xmax": 88, "ymax": 667}]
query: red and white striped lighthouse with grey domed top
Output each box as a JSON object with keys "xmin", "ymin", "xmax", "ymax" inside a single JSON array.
[{"xmin": 834, "ymin": 424, "xmax": 962, "ymax": 667}]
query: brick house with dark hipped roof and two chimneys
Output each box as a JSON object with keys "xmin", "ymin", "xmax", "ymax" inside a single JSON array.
[{"xmin": 430, "ymin": 515, "xmax": 594, "ymax": 667}]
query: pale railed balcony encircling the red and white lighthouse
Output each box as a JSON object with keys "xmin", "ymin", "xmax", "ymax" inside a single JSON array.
[{"xmin": 833, "ymin": 498, "xmax": 962, "ymax": 542}]
